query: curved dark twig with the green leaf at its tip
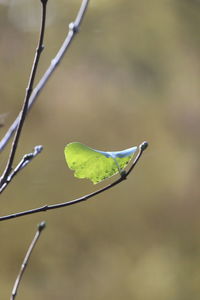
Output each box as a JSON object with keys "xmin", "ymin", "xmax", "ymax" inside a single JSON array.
[{"xmin": 0, "ymin": 142, "xmax": 148, "ymax": 221}]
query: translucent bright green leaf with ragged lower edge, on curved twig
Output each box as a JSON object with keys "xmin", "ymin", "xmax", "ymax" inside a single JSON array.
[{"xmin": 64, "ymin": 142, "xmax": 137, "ymax": 184}]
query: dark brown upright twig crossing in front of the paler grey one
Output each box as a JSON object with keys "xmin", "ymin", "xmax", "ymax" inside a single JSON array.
[{"xmin": 0, "ymin": 0, "xmax": 47, "ymax": 186}]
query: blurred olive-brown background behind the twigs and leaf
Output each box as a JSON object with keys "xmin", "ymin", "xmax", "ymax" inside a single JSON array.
[{"xmin": 0, "ymin": 0, "xmax": 200, "ymax": 300}]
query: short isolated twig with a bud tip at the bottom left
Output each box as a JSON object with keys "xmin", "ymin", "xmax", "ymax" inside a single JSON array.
[{"xmin": 10, "ymin": 221, "xmax": 46, "ymax": 300}]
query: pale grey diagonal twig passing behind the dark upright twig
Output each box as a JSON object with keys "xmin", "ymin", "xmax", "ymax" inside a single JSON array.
[{"xmin": 0, "ymin": 0, "xmax": 89, "ymax": 152}]
